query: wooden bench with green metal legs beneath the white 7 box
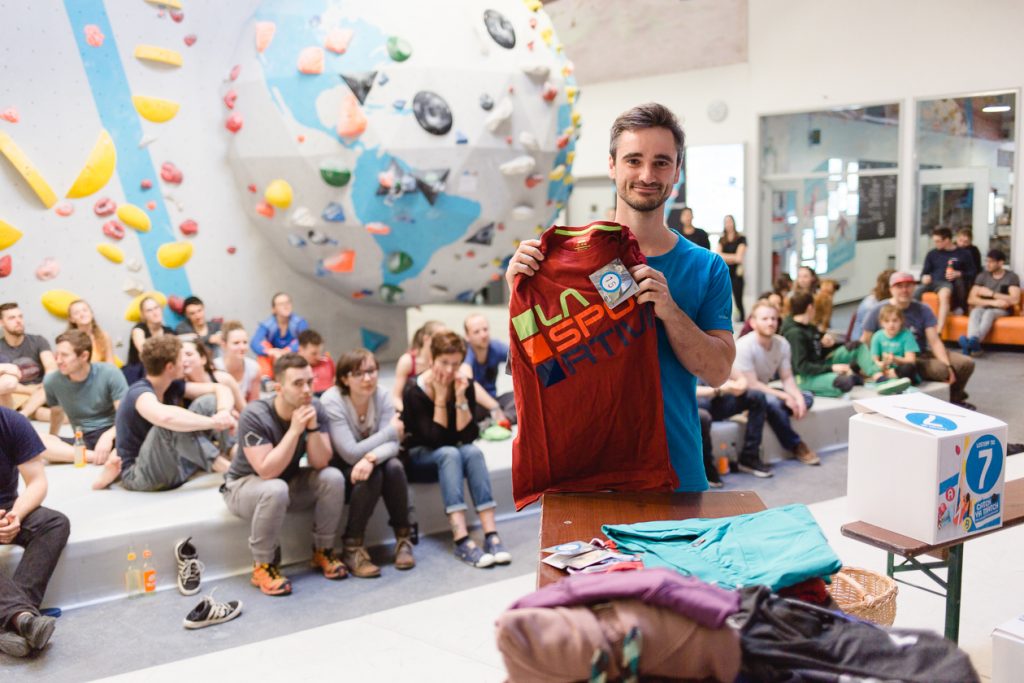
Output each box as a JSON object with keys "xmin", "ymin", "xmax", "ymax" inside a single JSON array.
[{"xmin": 843, "ymin": 479, "xmax": 1024, "ymax": 643}]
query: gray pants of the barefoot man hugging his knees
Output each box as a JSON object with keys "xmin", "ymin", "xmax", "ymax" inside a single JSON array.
[{"xmin": 121, "ymin": 394, "xmax": 226, "ymax": 490}]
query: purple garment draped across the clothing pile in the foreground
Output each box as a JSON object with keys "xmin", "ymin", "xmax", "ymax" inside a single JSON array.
[{"xmin": 509, "ymin": 567, "xmax": 739, "ymax": 629}]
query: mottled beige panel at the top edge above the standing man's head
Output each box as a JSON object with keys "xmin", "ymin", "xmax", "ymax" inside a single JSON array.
[{"xmin": 545, "ymin": 0, "xmax": 748, "ymax": 85}]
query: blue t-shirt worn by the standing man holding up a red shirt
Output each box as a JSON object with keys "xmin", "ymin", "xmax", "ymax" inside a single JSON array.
[{"xmin": 647, "ymin": 230, "xmax": 732, "ymax": 490}]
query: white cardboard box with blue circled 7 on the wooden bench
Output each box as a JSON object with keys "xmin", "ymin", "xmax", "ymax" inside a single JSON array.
[{"xmin": 847, "ymin": 393, "xmax": 1007, "ymax": 544}]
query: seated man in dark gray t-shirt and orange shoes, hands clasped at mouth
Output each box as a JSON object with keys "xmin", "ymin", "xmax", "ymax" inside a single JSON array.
[{"xmin": 221, "ymin": 353, "xmax": 348, "ymax": 595}]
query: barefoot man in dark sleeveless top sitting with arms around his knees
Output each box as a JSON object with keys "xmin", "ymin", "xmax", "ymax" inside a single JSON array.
[{"xmin": 93, "ymin": 334, "xmax": 237, "ymax": 490}]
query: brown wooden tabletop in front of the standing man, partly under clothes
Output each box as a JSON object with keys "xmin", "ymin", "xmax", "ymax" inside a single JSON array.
[{"xmin": 537, "ymin": 490, "xmax": 765, "ymax": 588}]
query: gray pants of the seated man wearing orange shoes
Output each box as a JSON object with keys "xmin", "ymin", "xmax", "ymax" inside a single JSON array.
[{"xmin": 224, "ymin": 467, "xmax": 345, "ymax": 563}]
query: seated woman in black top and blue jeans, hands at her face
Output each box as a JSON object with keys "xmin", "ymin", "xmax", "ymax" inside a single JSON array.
[{"xmin": 401, "ymin": 331, "xmax": 512, "ymax": 567}]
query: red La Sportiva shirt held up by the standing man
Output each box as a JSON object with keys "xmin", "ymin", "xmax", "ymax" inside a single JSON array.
[{"xmin": 509, "ymin": 221, "xmax": 678, "ymax": 509}]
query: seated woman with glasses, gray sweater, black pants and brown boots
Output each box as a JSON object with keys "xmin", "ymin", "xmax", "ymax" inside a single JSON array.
[{"xmin": 322, "ymin": 348, "xmax": 416, "ymax": 579}]
